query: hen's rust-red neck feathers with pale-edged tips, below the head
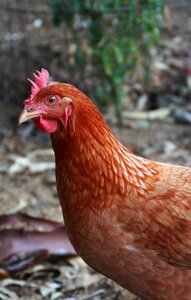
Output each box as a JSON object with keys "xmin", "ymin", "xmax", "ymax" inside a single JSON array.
[{"xmin": 52, "ymin": 109, "xmax": 156, "ymax": 209}]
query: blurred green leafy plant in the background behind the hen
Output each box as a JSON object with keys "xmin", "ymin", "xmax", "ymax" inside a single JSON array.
[{"xmin": 50, "ymin": 0, "xmax": 164, "ymax": 121}]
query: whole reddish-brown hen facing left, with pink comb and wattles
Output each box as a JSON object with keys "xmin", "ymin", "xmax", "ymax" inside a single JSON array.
[{"xmin": 20, "ymin": 70, "xmax": 191, "ymax": 300}]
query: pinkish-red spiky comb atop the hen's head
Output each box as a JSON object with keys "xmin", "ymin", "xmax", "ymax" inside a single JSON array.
[{"xmin": 24, "ymin": 68, "xmax": 49, "ymax": 105}]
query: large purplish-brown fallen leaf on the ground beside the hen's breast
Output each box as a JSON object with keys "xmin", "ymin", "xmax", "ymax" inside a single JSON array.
[{"xmin": 0, "ymin": 213, "xmax": 76, "ymax": 278}]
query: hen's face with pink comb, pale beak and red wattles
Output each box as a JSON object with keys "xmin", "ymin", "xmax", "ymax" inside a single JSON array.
[{"xmin": 19, "ymin": 69, "xmax": 78, "ymax": 133}]
